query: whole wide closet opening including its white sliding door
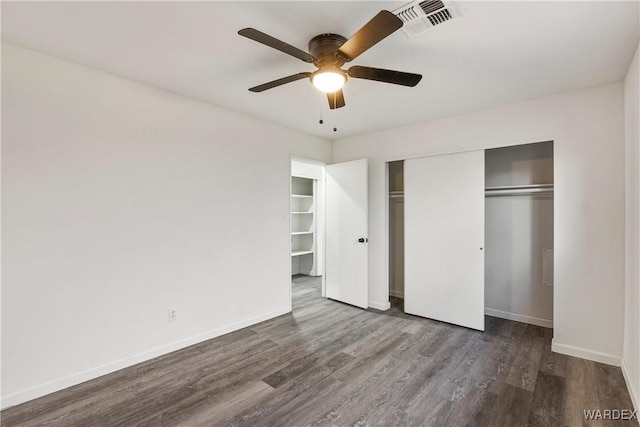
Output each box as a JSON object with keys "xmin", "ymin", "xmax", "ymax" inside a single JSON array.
[{"xmin": 387, "ymin": 141, "xmax": 554, "ymax": 330}]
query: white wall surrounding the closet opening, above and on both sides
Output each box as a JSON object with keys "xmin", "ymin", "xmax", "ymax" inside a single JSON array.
[{"xmin": 332, "ymin": 83, "xmax": 624, "ymax": 364}]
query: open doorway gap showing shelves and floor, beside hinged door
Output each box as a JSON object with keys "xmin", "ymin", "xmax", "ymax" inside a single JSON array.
[{"xmin": 290, "ymin": 159, "xmax": 325, "ymax": 306}]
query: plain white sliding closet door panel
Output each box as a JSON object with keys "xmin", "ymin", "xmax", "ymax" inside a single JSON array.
[{"xmin": 404, "ymin": 151, "xmax": 484, "ymax": 330}]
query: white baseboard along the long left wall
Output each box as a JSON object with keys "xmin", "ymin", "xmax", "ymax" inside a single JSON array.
[{"xmin": 0, "ymin": 307, "xmax": 291, "ymax": 409}]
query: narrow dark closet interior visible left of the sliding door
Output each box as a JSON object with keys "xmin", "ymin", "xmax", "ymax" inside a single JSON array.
[{"xmin": 388, "ymin": 160, "xmax": 404, "ymax": 298}]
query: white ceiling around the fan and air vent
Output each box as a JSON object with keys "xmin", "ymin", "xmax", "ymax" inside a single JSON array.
[{"xmin": 2, "ymin": 1, "xmax": 640, "ymax": 140}]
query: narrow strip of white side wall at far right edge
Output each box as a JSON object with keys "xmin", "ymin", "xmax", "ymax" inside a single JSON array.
[{"xmin": 622, "ymin": 42, "xmax": 640, "ymax": 409}]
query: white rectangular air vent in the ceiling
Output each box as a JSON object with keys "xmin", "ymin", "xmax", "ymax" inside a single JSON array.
[{"xmin": 393, "ymin": 0, "xmax": 459, "ymax": 37}]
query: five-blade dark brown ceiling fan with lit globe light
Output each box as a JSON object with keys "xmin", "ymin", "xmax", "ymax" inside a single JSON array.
[{"xmin": 238, "ymin": 10, "xmax": 422, "ymax": 109}]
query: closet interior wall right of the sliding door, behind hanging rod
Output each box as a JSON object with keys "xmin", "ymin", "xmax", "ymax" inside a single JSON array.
[{"xmin": 484, "ymin": 142, "xmax": 553, "ymax": 327}]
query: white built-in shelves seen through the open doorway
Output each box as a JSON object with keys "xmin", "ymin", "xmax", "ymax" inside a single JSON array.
[{"xmin": 291, "ymin": 176, "xmax": 316, "ymax": 275}]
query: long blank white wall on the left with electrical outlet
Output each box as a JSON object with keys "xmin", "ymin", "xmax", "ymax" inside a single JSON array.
[{"xmin": 2, "ymin": 43, "xmax": 330, "ymax": 407}]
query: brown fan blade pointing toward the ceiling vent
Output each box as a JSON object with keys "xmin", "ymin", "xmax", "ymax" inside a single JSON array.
[{"xmin": 338, "ymin": 10, "xmax": 402, "ymax": 62}]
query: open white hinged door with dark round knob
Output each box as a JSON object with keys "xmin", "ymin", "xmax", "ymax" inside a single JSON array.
[{"xmin": 325, "ymin": 159, "xmax": 369, "ymax": 308}]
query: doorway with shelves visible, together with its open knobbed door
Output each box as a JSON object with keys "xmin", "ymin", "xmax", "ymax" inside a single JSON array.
[{"xmin": 289, "ymin": 159, "xmax": 369, "ymax": 309}]
